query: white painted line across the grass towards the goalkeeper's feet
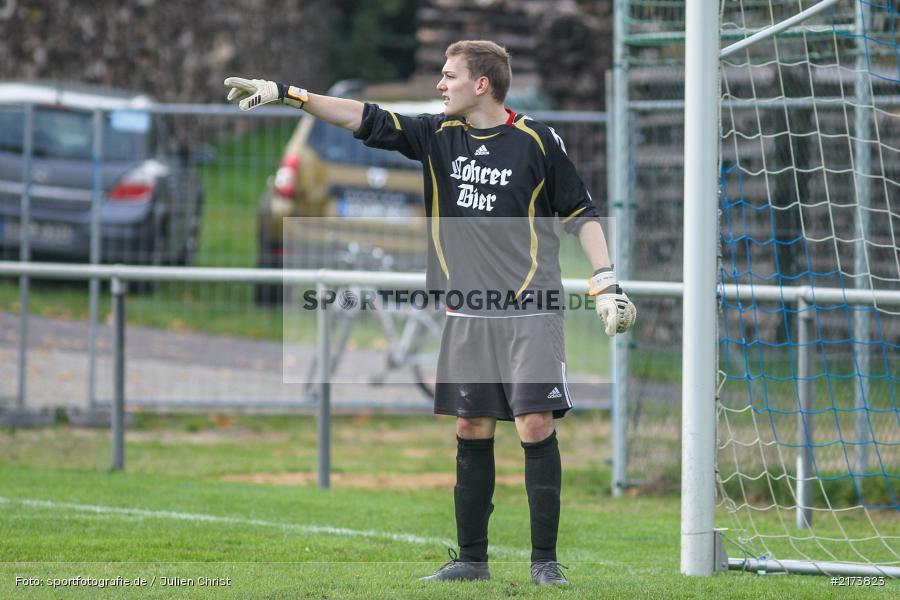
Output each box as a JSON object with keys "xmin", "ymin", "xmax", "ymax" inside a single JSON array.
[{"xmin": 0, "ymin": 496, "xmax": 531, "ymax": 560}]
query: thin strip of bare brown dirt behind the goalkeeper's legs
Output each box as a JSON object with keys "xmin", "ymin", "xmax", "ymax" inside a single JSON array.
[{"xmin": 221, "ymin": 472, "xmax": 525, "ymax": 490}]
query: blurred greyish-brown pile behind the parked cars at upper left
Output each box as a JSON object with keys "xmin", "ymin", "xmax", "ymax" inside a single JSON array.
[{"xmin": 0, "ymin": 0, "xmax": 335, "ymax": 102}]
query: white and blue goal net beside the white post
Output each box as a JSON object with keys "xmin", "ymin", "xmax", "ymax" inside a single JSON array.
[{"xmin": 716, "ymin": 0, "xmax": 900, "ymax": 575}]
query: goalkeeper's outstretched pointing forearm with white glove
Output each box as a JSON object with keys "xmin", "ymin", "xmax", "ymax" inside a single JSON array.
[{"xmin": 225, "ymin": 77, "xmax": 365, "ymax": 131}]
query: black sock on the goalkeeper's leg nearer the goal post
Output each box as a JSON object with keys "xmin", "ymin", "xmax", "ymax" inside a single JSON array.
[{"xmin": 522, "ymin": 431, "xmax": 562, "ymax": 562}]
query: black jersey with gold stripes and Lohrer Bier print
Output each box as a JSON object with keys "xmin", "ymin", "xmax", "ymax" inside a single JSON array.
[{"xmin": 354, "ymin": 103, "xmax": 599, "ymax": 314}]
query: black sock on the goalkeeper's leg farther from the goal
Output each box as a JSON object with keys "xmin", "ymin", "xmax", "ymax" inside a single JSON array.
[{"xmin": 453, "ymin": 436, "xmax": 494, "ymax": 562}]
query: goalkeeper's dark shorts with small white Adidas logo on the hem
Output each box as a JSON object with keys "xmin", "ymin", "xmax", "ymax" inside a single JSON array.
[{"xmin": 434, "ymin": 314, "xmax": 572, "ymax": 421}]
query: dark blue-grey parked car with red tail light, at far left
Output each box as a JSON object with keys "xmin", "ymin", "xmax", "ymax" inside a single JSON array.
[{"xmin": 0, "ymin": 82, "xmax": 203, "ymax": 264}]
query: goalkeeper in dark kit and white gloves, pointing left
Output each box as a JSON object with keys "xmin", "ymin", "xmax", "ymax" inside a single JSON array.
[{"xmin": 225, "ymin": 41, "xmax": 636, "ymax": 585}]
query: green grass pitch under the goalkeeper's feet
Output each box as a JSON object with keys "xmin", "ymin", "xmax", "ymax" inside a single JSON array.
[{"xmin": 0, "ymin": 413, "xmax": 897, "ymax": 600}]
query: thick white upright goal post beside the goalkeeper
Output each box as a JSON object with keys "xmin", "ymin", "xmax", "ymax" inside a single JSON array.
[{"xmin": 681, "ymin": 0, "xmax": 719, "ymax": 575}]
